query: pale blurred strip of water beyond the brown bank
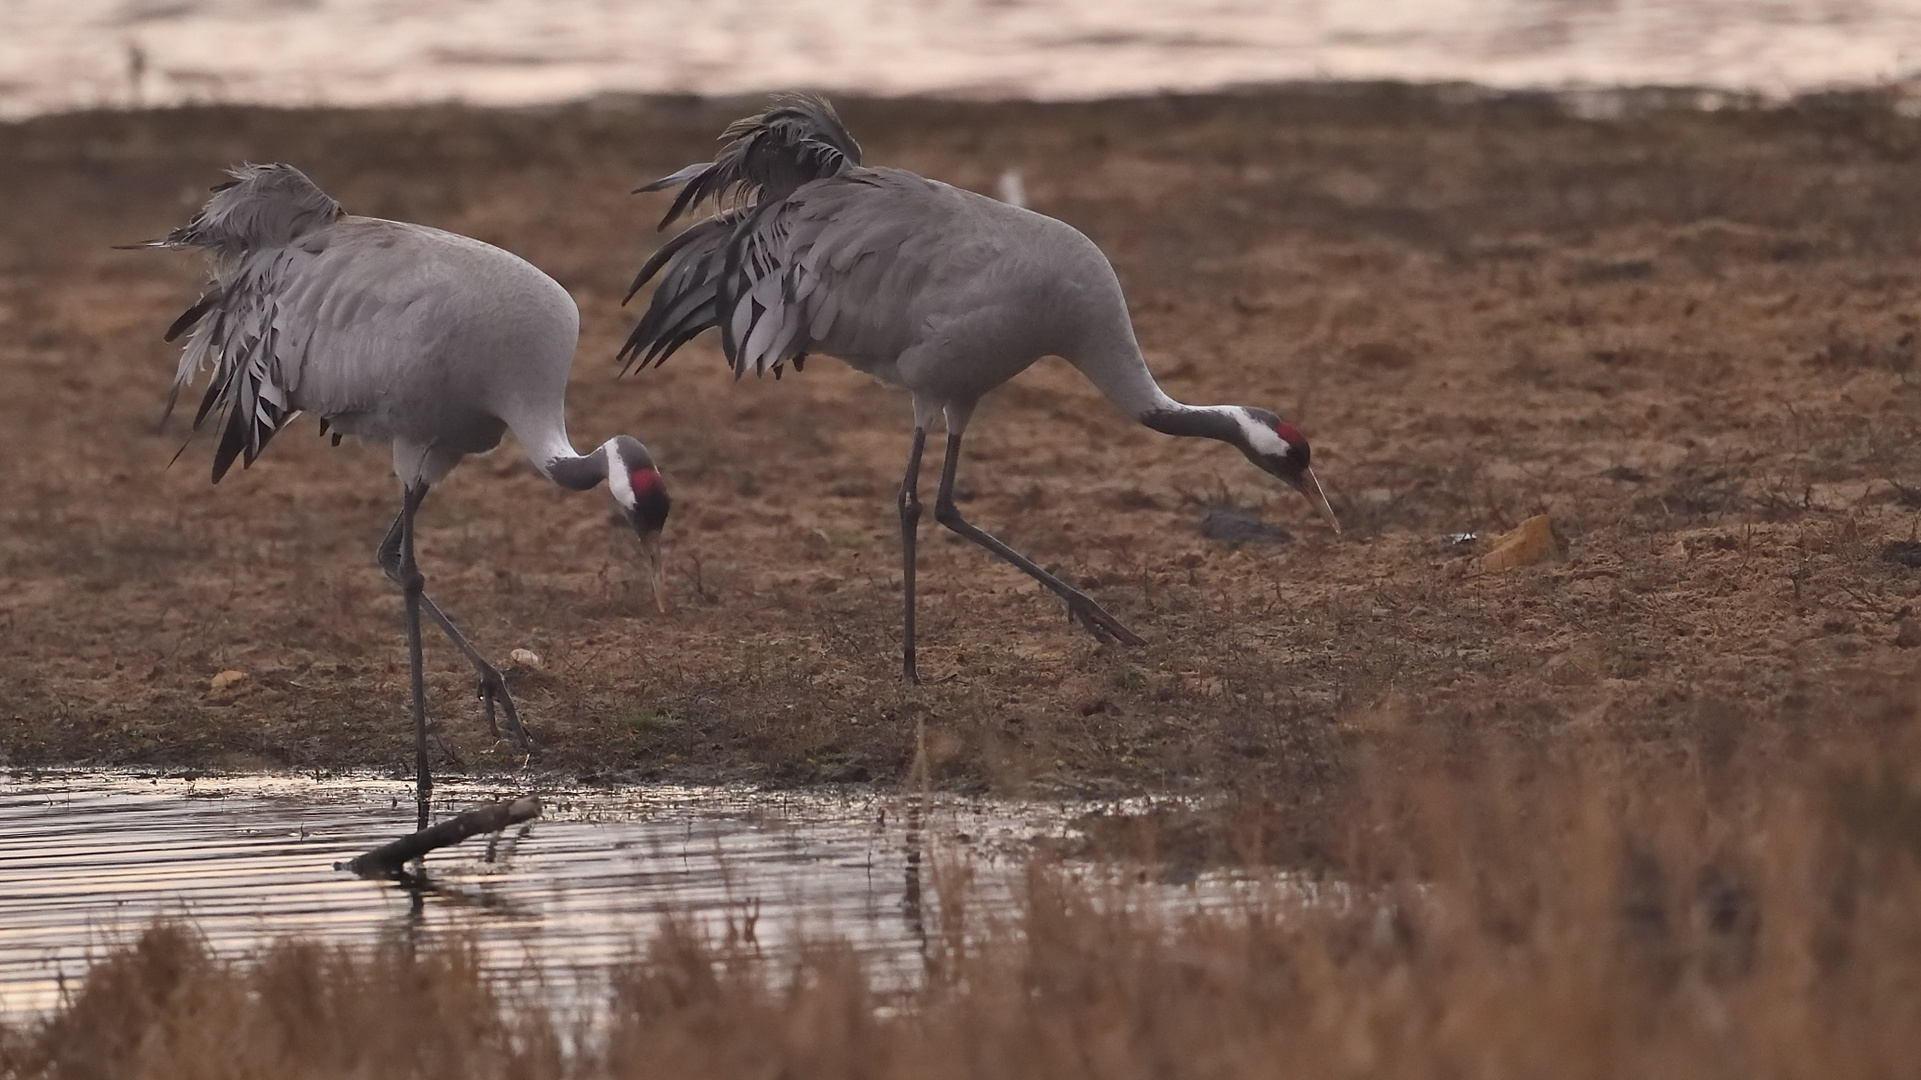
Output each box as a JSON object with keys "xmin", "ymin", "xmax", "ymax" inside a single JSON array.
[{"xmin": 0, "ymin": 0, "xmax": 1921, "ymax": 115}]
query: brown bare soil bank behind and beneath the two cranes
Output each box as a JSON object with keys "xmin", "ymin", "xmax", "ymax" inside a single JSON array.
[{"xmin": 0, "ymin": 86, "xmax": 1921, "ymax": 799}]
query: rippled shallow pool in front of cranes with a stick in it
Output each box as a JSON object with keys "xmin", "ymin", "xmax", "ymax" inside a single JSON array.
[{"xmin": 0, "ymin": 773, "xmax": 1068, "ymax": 1015}]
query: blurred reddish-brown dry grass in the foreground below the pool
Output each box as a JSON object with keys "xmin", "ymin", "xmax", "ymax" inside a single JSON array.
[{"xmin": 11, "ymin": 719, "xmax": 1921, "ymax": 1078}]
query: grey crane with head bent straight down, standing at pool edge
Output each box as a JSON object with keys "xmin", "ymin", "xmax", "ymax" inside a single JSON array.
[{"xmin": 131, "ymin": 165, "xmax": 669, "ymax": 810}]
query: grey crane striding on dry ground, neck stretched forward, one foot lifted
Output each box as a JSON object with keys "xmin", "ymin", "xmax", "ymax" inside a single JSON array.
[{"xmin": 620, "ymin": 94, "xmax": 1339, "ymax": 682}]
